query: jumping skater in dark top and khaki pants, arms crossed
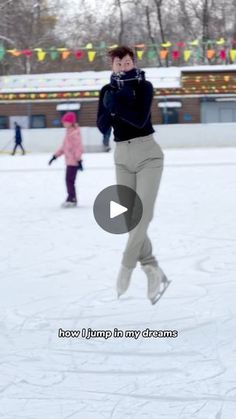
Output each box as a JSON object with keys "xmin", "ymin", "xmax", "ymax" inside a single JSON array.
[{"xmin": 97, "ymin": 46, "xmax": 168, "ymax": 303}]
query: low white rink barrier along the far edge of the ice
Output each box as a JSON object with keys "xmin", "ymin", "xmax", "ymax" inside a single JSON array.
[{"xmin": 0, "ymin": 123, "xmax": 236, "ymax": 152}]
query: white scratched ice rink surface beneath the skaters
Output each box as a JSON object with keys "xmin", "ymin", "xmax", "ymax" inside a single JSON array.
[{"xmin": 0, "ymin": 149, "xmax": 236, "ymax": 419}]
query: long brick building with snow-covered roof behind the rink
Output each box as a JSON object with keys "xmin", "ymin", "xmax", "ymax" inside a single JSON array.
[{"xmin": 0, "ymin": 65, "xmax": 236, "ymax": 129}]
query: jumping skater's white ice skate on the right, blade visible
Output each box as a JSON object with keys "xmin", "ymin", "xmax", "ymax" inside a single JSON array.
[{"xmin": 142, "ymin": 265, "xmax": 170, "ymax": 304}]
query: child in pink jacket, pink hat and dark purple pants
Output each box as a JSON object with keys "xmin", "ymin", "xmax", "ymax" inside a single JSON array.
[{"xmin": 48, "ymin": 112, "xmax": 83, "ymax": 208}]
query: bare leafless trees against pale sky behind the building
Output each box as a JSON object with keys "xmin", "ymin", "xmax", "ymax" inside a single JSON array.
[{"xmin": 0, "ymin": 0, "xmax": 236, "ymax": 74}]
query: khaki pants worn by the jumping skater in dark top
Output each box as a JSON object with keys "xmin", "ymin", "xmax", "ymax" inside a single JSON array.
[{"xmin": 114, "ymin": 135, "xmax": 164, "ymax": 268}]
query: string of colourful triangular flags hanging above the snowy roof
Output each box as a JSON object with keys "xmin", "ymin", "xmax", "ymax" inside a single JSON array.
[{"xmin": 0, "ymin": 38, "xmax": 236, "ymax": 63}]
